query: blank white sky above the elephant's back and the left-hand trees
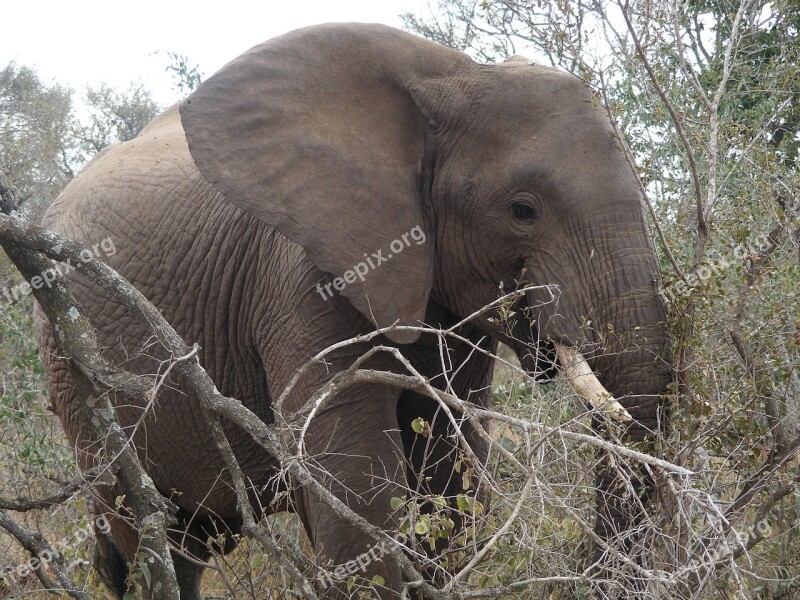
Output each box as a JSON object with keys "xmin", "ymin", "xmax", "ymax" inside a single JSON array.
[{"xmin": 0, "ymin": 0, "xmax": 427, "ymax": 105}]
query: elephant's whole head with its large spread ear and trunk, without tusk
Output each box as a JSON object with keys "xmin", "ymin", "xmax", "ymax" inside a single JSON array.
[{"xmin": 181, "ymin": 24, "xmax": 669, "ymax": 436}]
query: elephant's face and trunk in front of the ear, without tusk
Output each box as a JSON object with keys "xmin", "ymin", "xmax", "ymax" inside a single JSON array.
[{"xmin": 417, "ymin": 59, "xmax": 669, "ymax": 434}]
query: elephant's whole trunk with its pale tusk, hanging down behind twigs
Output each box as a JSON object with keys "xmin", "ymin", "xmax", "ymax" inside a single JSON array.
[{"xmin": 527, "ymin": 224, "xmax": 671, "ymax": 584}]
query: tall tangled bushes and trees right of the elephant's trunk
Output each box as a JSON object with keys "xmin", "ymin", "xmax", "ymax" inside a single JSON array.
[{"xmin": 404, "ymin": 0, "xmax": 800, "ymax": 598}]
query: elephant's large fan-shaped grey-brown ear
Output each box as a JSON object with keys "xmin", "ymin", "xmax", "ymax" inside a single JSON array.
[{"xmin": 180, "ymin": 24, "xmax": 470, "ymax": 343}]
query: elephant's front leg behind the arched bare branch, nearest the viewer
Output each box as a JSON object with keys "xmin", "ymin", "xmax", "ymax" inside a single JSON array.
[{"xmin": 295, "ymin": 385, "xmax": 406, "ymax": 598}]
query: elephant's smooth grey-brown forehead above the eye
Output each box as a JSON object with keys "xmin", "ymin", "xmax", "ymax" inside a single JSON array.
[{"xmin": 457, "ymin": 74, "xmax": 638, "ymax": 202}]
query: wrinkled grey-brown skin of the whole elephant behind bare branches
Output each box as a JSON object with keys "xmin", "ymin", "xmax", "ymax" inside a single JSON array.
[{"xmin": 41, "ymin": 24, "xmax": 669, "ymax": 598}]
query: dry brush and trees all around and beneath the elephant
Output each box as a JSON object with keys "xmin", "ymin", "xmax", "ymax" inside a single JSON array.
[{"xmin": 0, "ymin": 0, "xmax": 800, "ymax": 600}]
